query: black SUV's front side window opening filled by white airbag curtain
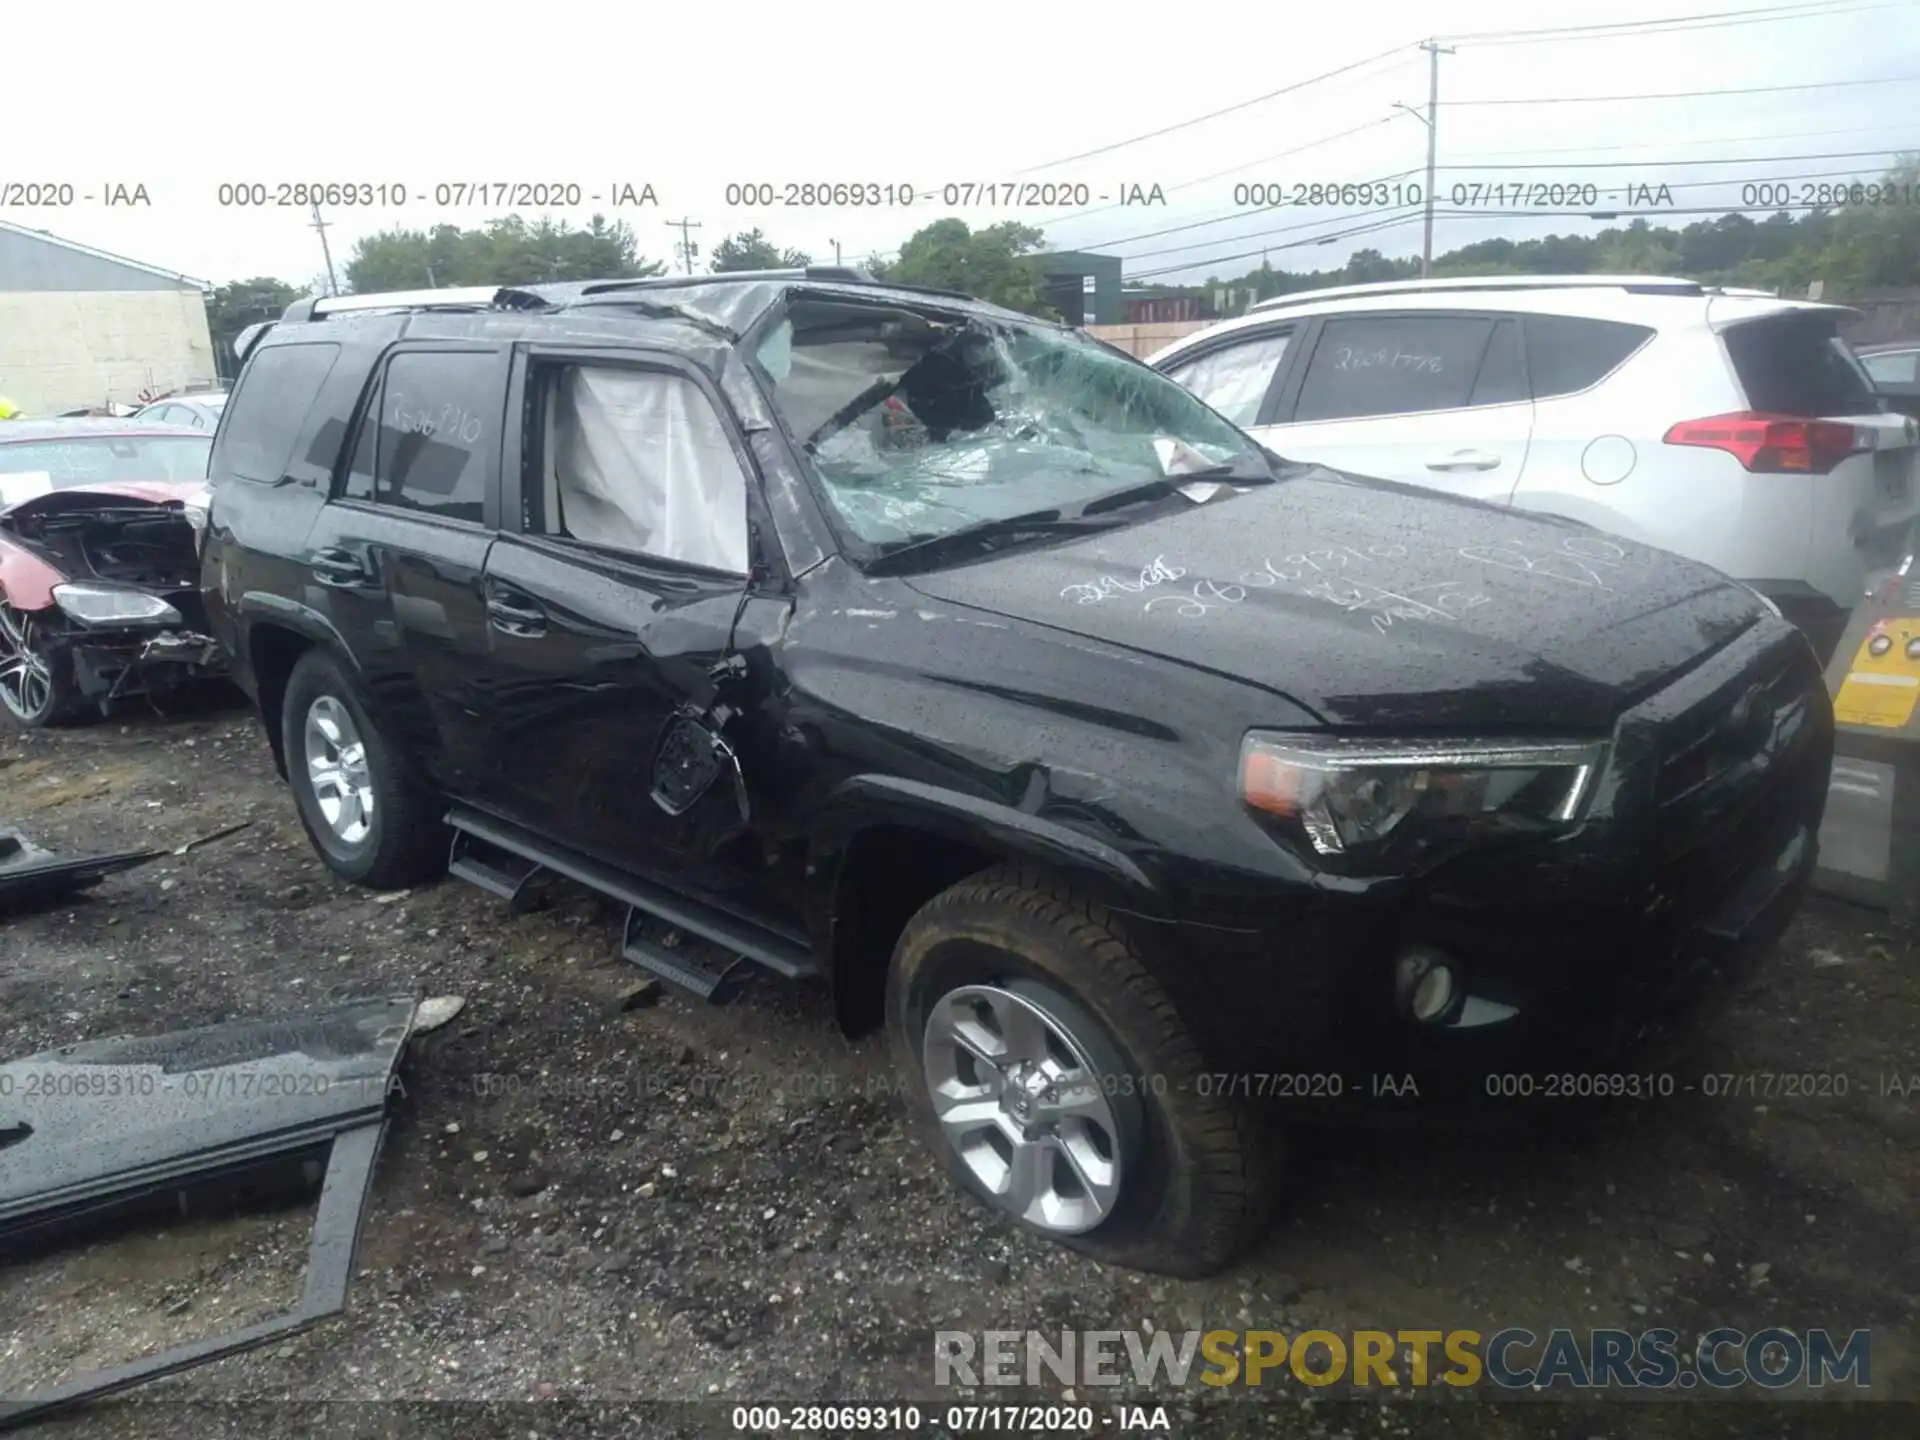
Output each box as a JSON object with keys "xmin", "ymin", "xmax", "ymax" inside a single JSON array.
[{"xmin": 540, "ymin": 365, "xmax": 749, "ymax": 574}]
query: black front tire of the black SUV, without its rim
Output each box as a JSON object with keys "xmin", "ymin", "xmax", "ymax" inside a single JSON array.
[{"xmin": 887, "ymin": 866, "xmax": 1281, "ymax": 1277}]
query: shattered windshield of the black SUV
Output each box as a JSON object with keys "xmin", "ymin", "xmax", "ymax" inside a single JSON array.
[{"xmin": 756, "ymin": 298, "xmax": 1273, "ymax": 549}]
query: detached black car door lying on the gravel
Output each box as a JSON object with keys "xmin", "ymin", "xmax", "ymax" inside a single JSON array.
[{"xmin": 0, "ymin": 996, "xmax": 465, "ymax": 1430}]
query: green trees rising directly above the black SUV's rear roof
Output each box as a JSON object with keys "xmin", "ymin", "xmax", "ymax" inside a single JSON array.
[{"xmin": 346, "ymin": 215, "xmax": 666, "ymax": 294}]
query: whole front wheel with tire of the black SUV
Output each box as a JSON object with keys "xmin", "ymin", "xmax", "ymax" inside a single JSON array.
[{"xmin": 887, "ymin": 866, "xmax": 1281, "ymax": 1277}]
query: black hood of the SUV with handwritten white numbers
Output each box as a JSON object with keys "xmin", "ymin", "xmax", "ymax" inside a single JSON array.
[{"xmin": 908, "ymin": 468, "xmax": 1764, "ymax": 733}]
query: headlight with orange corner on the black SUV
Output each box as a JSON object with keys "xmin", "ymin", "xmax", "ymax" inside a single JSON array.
[{"xmin": 1240, "ymin": 733, "xmax": 1607, "ymax": 854}]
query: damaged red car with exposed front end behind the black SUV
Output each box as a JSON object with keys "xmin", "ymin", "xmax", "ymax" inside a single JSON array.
[{"xmin": 0, "ymin": 419, "xmax": 225, "ymax": 726}]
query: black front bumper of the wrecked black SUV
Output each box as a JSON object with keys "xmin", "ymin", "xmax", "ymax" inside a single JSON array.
[{"xmin": 1165, "ymin": 622, "xmax": 1834, "ymax": 1108}]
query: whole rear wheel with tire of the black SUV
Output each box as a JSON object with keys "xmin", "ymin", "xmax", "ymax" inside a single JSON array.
[{"xmin": 280, "ymin": 649, "xmax": 447, "ymax": 889}]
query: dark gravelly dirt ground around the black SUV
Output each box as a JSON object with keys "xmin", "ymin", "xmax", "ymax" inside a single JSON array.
[{"xmin": 0, "ymin": 699, "xmax": 1920, "ymax": 1440}]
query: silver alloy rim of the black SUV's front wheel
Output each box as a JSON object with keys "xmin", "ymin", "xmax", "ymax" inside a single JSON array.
[{"xmin": 922, "ymin": 985, "xmax": 1121, "ymax": 1235}]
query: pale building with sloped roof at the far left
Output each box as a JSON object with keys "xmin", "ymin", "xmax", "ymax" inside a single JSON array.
[{"xmin": 0, "ymin": 221, "xmax": 217, "ymax": 415}]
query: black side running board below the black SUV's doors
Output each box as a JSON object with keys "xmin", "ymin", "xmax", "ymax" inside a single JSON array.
[{"xmin": 447, "ymin": 808, "xmax": 820, "ymax": 1004}]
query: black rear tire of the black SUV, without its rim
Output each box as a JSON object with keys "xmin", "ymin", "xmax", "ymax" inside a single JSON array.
[{"xmin": 280, "ymin": 649, "xmax": 449, "ymax": 891}]
